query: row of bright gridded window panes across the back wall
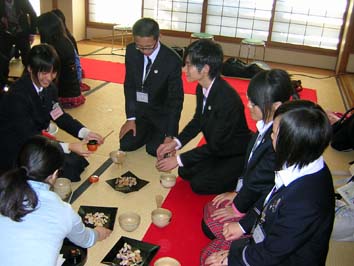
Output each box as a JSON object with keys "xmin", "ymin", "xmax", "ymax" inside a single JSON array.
[{"xmin": 88, "ymin": 0, "xmax": 348, "ymax": 50}]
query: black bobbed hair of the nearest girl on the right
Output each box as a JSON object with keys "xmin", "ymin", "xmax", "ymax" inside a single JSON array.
[{"xmin": 274, "ymin": 100, "xmax": 332, "ymax": 170}]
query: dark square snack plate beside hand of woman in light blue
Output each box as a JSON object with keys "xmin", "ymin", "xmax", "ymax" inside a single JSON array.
[{"xmin": 79, "ymin": 206, "xmax": 118, "ymax": 230}]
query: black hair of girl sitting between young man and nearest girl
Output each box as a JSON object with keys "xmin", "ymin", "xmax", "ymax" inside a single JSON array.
[{"xmin": 247, "ymin": 69, "xmax": 293, "ymax": 121}]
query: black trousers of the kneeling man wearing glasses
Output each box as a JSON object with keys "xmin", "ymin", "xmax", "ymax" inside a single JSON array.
[{"xmin": 120, "ymin": 117, "xmax": 165, "ymax": 157}]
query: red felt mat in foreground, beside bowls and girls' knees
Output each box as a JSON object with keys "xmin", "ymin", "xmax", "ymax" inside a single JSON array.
[{"xmin": 143, "ymin": 177, "xmax": 214, "ymax": 266}]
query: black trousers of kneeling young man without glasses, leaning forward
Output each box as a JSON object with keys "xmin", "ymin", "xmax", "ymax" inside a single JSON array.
[{"xmin": 178, "ymin": 156, "xmax": 244, "ymax": 194}]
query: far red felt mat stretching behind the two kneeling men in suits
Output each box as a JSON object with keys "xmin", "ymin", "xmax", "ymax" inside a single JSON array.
[{"xmin": 81, "ymin": 58, "xmax": 317, "ymax": 131}]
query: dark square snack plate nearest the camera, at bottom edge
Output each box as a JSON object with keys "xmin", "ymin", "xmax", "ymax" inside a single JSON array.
[{"xmin": 101, "ymin": 236, "xmax": 160, "ymax": 266}]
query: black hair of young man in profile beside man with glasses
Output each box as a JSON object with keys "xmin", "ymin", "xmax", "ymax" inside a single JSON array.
[{"xmin": 183, "ymin": 39, "xmax": 224, "ymax": 79}]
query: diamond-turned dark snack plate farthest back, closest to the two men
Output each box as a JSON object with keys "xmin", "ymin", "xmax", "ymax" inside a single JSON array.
[{"xmin": 106, "ymin": 171, "xmax": 149, "ymax": 193}]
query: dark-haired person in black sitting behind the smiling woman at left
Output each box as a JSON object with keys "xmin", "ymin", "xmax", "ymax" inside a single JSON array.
[{"xmin": 37, "ymin": 12, "xmax": 85, "ymax": 108}]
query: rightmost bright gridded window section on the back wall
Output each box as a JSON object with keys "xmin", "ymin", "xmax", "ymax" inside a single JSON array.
[{"xmin": 271, "ymin": 0, "xmax": 347, "ymax": 50}]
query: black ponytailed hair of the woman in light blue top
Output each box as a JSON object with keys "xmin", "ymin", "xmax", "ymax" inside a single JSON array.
[{"xmin": 0, "ymin": 136, "xmax": 64, "ymax": 222}]
